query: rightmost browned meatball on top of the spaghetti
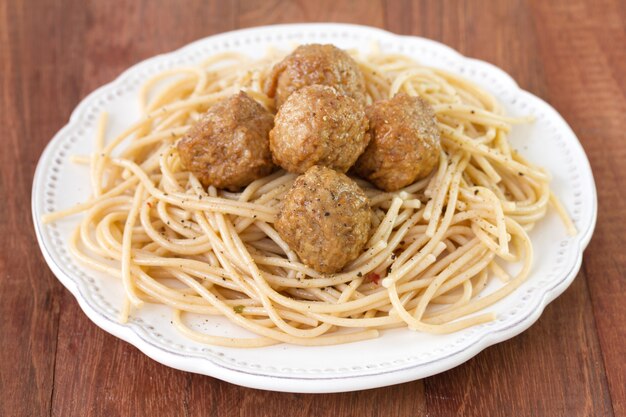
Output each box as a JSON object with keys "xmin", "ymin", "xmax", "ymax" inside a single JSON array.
[{"xmin": 355, "ymin": 94, "xmax": 441, "ymax": 191}]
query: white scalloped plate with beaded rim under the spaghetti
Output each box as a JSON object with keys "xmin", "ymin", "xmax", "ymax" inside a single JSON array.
[{"xmin": 32, "ymin": 24, "xmax": 597, "ymax": 392}]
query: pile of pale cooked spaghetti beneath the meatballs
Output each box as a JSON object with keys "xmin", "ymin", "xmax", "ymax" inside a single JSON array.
[{"xmin": 44, "ymin": 45, "xmax": 573, "ymax": 347}]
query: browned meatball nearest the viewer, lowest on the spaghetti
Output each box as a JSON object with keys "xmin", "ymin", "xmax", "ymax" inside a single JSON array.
[{"xmin": 274, "ymin": 166, "xmax": 371, "ymax": 274}]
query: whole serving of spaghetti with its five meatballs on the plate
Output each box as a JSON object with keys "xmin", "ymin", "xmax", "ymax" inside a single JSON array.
[{"xmin": 43, "ymin": 45, "xmax": 573, "ymax": 347}]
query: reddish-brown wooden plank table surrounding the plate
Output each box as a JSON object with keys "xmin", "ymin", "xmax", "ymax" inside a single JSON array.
[{"xmin": 0, "ymin": 0, "xmax": 626, "ymax": 417}]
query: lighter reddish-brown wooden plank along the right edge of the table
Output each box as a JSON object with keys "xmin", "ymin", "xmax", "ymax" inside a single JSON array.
[{"xmin": 532, "ymin": 0, "xmax": 626, "ymax": 416}]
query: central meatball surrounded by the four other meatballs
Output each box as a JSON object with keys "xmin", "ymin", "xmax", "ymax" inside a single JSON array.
[{"xmin": 270, "ymin": 85, "xmax": 369, "ymax": 173}]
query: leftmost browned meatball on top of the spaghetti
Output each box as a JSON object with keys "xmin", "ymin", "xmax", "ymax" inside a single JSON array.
[{"xmin": 178, "ymin": 92, "xmax": 274, "ymax": 191}]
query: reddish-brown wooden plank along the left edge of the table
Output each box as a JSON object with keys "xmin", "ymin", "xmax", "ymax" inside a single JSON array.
[{"xmin": 0, "ymin": 2, "xmax": 81, "ymax": 416}]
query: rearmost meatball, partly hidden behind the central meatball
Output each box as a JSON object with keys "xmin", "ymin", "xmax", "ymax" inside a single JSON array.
[{"xmin": 266, "ymin": 44, "xmax": 365, "ymax": 109}]
